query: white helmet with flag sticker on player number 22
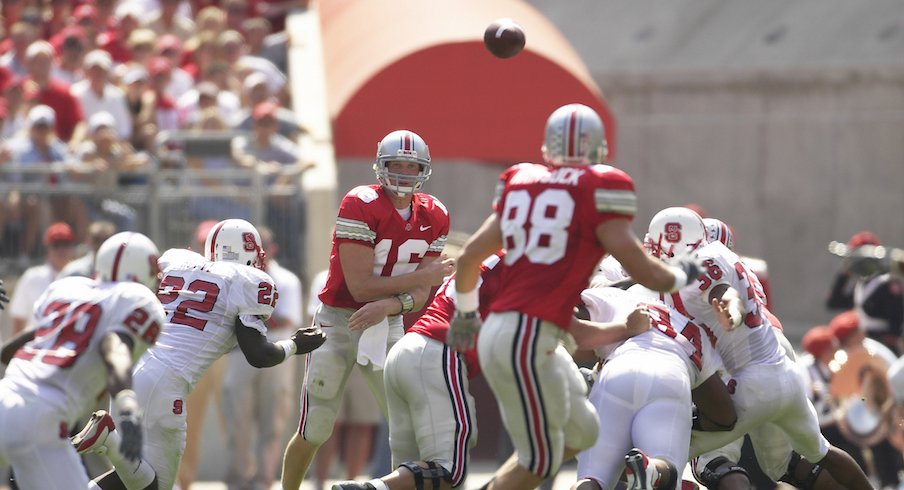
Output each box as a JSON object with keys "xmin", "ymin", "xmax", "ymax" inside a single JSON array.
[{"xmin": 204, "ymin": 219, "xmax": 266, "ymax": 270}]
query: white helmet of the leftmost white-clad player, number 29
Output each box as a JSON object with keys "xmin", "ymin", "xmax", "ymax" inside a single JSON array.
[{"xmin": 94, "ymin": 231, "xmax": 160, "ymax": 293}]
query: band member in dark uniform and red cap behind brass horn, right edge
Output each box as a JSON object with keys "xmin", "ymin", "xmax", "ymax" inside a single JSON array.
[{"xmin": 826, "ymin": 231, "xmax": 904, "ymax": 355}]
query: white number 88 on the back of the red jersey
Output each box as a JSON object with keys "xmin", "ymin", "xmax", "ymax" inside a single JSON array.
[{"xmin": 502, "ymin": 189, "xmax": 574, "ymax": 265}]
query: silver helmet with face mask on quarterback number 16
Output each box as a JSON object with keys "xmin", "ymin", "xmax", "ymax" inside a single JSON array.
[{"xmin": 374, "ymin": 129, "xmax": 433, "ymax": 195}]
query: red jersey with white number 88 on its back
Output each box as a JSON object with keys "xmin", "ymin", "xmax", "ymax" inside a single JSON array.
[{"xmin": 490, "ymin": 163, "xmax": 637, "ymax": 330}]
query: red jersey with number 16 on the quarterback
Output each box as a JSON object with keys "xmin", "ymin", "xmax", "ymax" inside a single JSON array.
[{"xmin": 319, "ymin": 184, "xmax": 449, "ymax": 309}]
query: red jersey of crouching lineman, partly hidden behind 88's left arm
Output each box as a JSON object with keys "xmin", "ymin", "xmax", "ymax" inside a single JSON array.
[{"xmin": 408, "ymin": 255, "xmax": 502, "ymax": 378}]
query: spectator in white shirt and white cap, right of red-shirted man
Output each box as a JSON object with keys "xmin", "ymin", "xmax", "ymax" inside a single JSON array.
[{"xmin": 69, "ymin": 49, "xmax": 134, "ymax": 139}]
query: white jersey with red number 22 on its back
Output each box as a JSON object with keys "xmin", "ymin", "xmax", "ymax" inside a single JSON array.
[{"xmin": 148, "ymin": 249, "xmax": 279, "ymax": 388}]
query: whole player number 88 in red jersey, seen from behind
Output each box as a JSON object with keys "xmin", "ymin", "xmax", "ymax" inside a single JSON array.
[{"xmin": 447, "ymin": 104, "xmax": 698, "ymax": 490}]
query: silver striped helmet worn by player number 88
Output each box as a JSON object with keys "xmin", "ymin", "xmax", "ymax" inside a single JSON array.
[{"xmin": 542, "ymin": 104, "xmax": 608, "ymax": 165}]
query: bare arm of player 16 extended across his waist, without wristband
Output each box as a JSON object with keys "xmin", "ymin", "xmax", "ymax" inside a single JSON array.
[{"xmin": 339, "ymin": 243, "xmax": 455, "ymax": 303}]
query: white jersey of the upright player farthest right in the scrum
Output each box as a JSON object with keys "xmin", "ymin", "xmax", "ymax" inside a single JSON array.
[{"xmin": 662, "ymin": 242, "xmax": 784, "ymax": 373}]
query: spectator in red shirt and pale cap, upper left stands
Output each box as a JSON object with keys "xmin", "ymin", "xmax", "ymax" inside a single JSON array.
[{"xmin": 25, "ymin": 41, "xmax": 84, "ymax": 142}]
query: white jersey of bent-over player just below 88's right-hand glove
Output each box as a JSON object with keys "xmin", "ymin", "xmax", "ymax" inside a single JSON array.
[{"xmin": 581, "ymin": 288, "xmax": 722, "ymax": 388}]
